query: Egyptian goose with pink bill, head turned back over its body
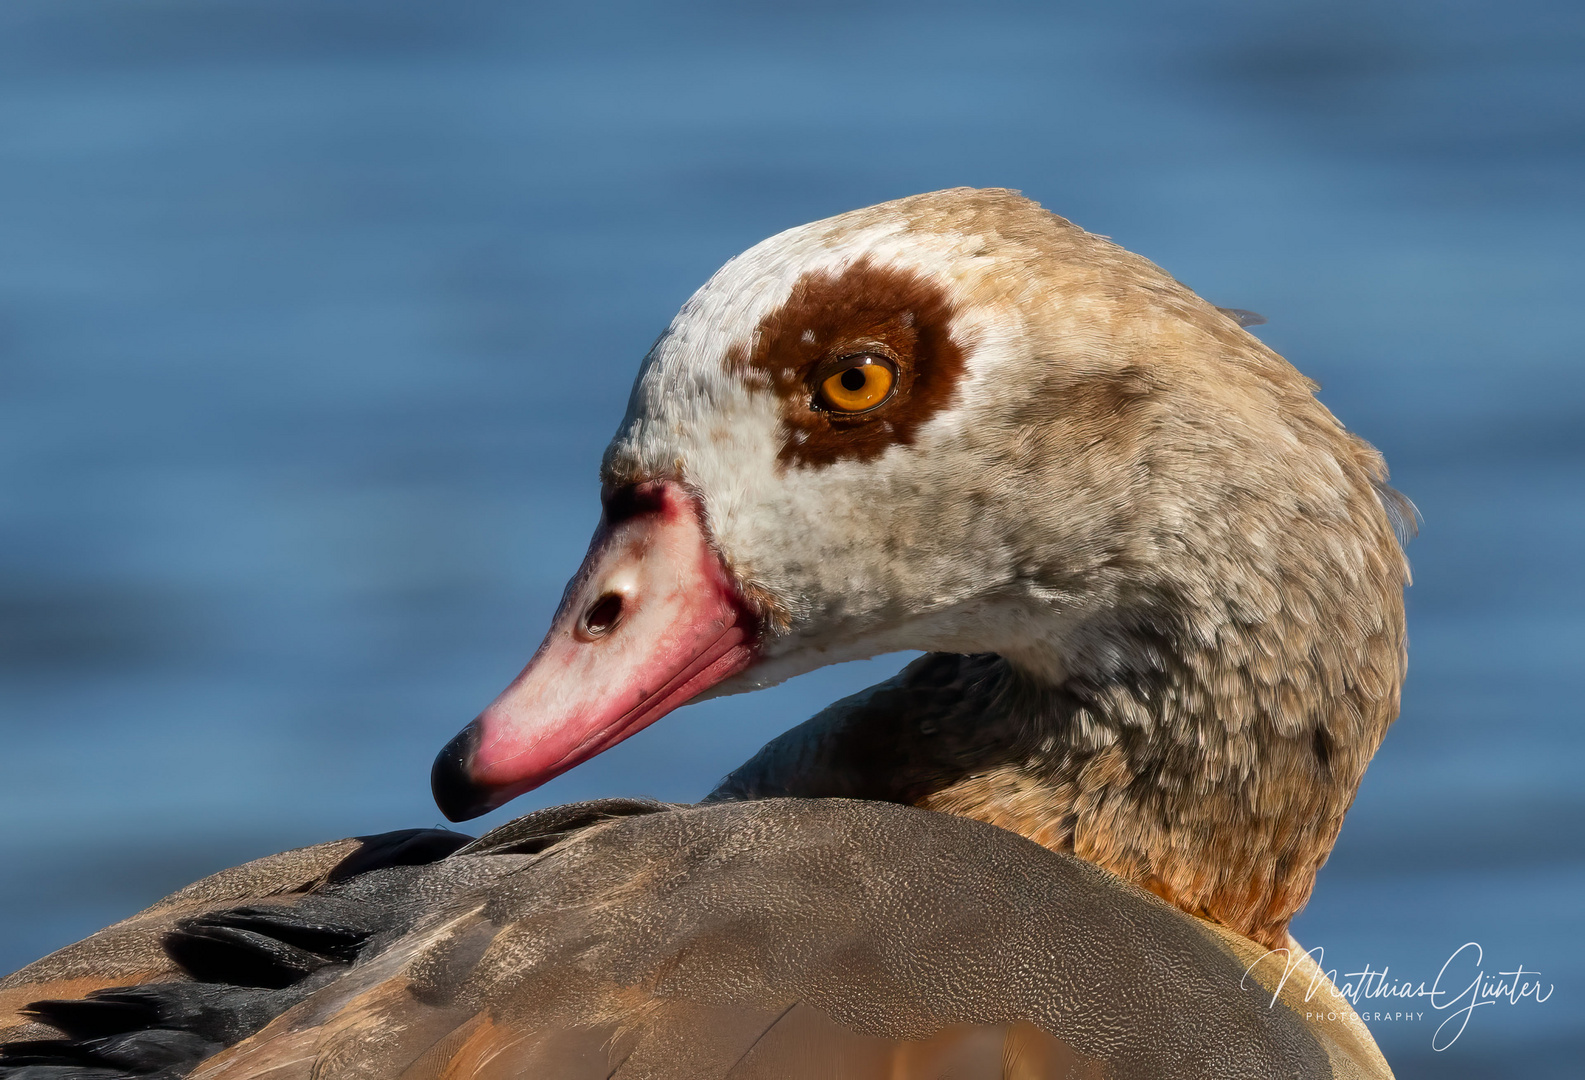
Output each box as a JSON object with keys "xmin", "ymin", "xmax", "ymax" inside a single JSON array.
[{"xmin": 0, "ymin": 189, "xmax": 1407, "ymax": 1080}]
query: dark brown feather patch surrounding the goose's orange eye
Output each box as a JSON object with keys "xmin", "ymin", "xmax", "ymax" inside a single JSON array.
[{"xmin": 729, "ymin": 259, "xmax": 964, "ymax": 466}]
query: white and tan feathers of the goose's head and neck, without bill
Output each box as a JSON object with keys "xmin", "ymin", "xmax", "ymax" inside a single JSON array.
[{"xmin": 624, "ymin": 190, "xmax": 1412, "ymax": 945}]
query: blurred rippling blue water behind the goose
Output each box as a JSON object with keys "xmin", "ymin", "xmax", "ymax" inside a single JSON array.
[{"xmin": 0, "ymin": 0, "xmax": 1585, "ymax": 1077}]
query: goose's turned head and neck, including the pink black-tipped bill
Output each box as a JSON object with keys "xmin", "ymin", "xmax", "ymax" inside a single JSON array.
[{"xmin": 434, "ymin": 189, "xmax": 1406, "ymax": 940}]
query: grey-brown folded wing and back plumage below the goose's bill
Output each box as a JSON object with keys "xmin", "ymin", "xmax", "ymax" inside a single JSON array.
[{"xmin": 0, "ymin": 799, "xmax": 1363, "ymax": 1080}]
